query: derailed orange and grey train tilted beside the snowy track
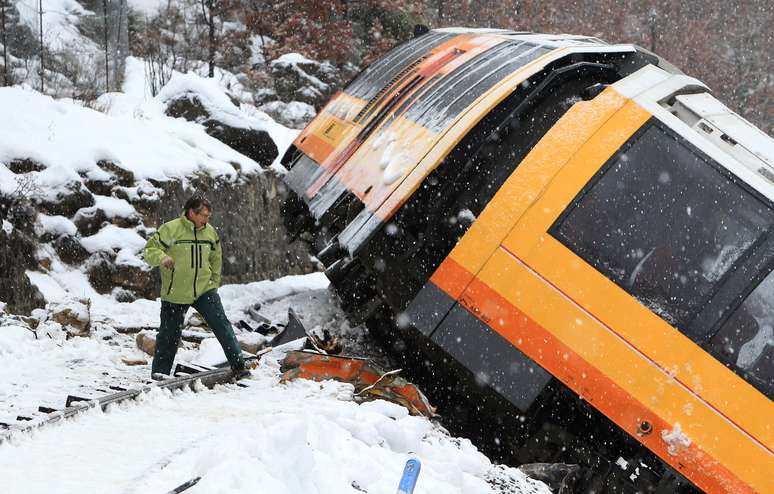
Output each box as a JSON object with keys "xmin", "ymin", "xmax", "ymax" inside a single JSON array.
[{"xmin": 283, "ymin": 29, "xmax": 774, "ymax": 493}]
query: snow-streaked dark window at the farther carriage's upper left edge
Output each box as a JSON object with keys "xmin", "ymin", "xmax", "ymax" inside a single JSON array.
[{"xmin": 344, "ymin": 32, "xmax": 456, "ymax": 100}]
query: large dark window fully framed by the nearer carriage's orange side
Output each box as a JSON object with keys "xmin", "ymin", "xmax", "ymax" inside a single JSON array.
[{"xmin": 550, "ymin": 123, "xmax": 774, "ymax": 332}]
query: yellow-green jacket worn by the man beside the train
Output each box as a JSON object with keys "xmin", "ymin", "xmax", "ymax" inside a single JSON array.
[{"xmin": 145, "ymin": 215, "xmax": 223, "ymax": 304}]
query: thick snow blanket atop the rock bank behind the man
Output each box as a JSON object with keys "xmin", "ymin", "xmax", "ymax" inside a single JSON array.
[{"xmin": 0, "ymin": 87, "xmax": 260, "ymax": 183}]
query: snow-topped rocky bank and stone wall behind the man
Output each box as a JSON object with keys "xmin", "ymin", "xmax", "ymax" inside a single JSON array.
[{"xmin": 0, "ymin": 71, "xmax": 314, "ymax": 312}]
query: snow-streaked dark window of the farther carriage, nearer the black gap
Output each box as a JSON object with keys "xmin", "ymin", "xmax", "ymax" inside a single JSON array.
[{"xmin": 405, "ymin": 41, "xmax": 550, "ymax": 131}]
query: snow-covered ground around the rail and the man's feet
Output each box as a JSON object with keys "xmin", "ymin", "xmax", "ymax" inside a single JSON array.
[{"xmin": 0, "ymin": 273, "xmax": 550, "ymax": 494}]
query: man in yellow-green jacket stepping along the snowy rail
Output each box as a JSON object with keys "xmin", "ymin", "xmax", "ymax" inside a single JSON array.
[{"xmin": 145, "ymin": 196, "xmax": 249, "ymax": 378}]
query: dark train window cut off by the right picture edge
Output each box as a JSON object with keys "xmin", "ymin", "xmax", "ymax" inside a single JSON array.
[{"xmin": 709, "ymin": 271, "xmax": 774, "ymax": 399}]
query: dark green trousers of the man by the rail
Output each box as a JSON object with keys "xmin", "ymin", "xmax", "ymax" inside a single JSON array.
[{"xmin": 151, "ymin": 290, "xmax": 245, "ymax": 375}]
